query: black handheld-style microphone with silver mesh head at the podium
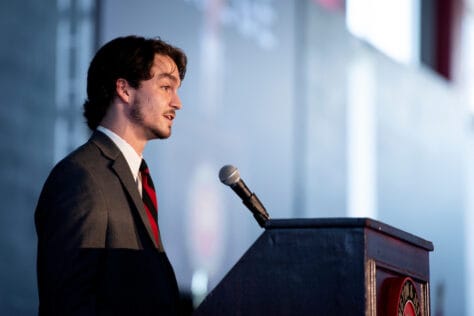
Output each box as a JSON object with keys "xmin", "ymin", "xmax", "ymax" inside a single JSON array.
[{"xmin": 219, "ymin": 165, "xmax": 270, "ymax": 228}]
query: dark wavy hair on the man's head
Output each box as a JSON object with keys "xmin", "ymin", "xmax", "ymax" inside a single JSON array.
[{"xmin": 84, "ymin": 36, "xmax": 187, "ymax": 130}]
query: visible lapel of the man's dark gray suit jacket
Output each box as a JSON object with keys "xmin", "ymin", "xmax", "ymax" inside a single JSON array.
[{"xmin": 91, "ymin": 131, "xmax": 160, "ymax": 248}]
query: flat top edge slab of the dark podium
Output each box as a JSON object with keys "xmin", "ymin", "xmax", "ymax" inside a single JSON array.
[{"xmin": 265, "ymin": 217, "xmax": 434, "ymax": 251}]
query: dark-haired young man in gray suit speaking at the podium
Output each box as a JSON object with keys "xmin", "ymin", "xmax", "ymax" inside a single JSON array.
[{"xmin": 35, "ymin": 36, "xmax": 187, "ymax": 316}]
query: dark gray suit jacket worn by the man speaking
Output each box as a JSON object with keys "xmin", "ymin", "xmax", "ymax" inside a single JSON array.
[{"xmin": 35, "ymin": 132, "xmax": 179, "ymax": 315}]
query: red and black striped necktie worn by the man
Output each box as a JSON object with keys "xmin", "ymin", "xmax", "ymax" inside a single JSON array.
[{"xmin": 140, "ymin": 159, "xmax": 163, "ymax": 249}]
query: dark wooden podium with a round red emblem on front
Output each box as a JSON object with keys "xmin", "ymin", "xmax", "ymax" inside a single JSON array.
[{"xmin": 194, "ymin": 218, "xmax": 433, "ymax": 316}]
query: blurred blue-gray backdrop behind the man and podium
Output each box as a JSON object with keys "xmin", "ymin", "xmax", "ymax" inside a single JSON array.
[{"xmin": 0, "ymin": 0, "xmax": 474, "ymax": 316}]
